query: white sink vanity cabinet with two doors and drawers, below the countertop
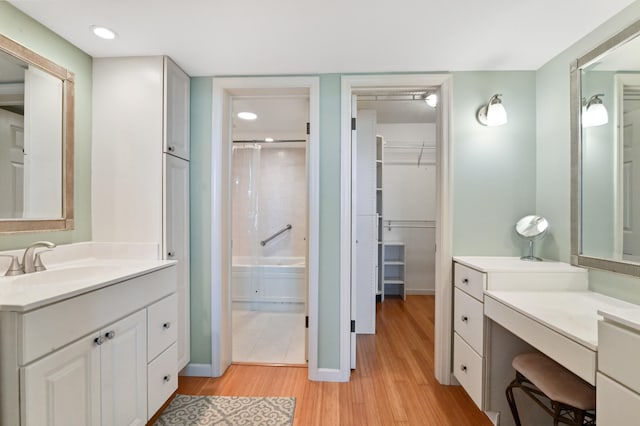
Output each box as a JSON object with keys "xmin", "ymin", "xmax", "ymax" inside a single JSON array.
[{"xmin": 0, "ymin": 265, "xmax": 178, "ymax": 426}]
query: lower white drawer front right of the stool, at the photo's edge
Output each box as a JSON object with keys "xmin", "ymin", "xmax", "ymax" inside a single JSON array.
[{"xmin": 596, "ymin": 373, "xmax": 640, "ymax": 426}]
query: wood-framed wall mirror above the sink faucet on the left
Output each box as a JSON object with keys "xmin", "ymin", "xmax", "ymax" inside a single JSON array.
[{"xmin": 0, "ymin": 35, "xmax": 74, "ymax": 232}]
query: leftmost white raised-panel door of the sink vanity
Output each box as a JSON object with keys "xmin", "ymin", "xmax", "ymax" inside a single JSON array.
[{"xmin": 20, "ymin": 333, "xmax": 100, "ymax": 426}]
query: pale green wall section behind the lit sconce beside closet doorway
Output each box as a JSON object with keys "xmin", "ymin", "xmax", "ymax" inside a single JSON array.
[{"xmin": 452, "ymin": 71, "xmax": 536, "ymax": 256}]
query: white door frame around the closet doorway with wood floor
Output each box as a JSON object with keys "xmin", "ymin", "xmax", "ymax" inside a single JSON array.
[{"xmin": 340, "ymin": 74, "xmax": 453, "ymax": 385}]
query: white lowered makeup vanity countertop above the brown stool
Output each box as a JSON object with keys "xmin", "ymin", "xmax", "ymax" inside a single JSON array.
[{"xmin": 485, "ymin": 290, "xmax": 640, "ymax": 351}]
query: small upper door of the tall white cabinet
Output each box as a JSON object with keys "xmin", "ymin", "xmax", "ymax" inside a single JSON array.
[{"xmin": 164, "ymin": 58, "xmax": 191, "ymax": 160}]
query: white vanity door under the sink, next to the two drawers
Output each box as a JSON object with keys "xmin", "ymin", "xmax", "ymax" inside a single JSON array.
[{"xmin": 100, "ymin": 309, "xmax": 147, "ymax": 426}]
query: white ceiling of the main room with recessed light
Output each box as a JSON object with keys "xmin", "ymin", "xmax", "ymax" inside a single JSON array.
[{"xmin": 10, "ymin": 0, "xmax": 633, "ymax": 76}]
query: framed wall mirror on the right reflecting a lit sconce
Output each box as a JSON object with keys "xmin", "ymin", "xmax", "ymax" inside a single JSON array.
[{"xmin": 571, "ymin": 21, "xmax": 640, "ymax": 276}]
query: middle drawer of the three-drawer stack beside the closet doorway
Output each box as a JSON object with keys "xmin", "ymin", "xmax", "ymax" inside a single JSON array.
[{"xmin": 453, "ymin": 288, "xmax": 484, "ymax": 355}]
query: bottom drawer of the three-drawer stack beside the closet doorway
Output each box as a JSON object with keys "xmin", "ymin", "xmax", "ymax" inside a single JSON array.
[{"xmin": 453, "ymin": 333, "xmax": 482, "ymax": 409}]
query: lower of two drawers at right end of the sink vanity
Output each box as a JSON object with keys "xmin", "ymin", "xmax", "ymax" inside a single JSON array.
[{"xmin": 147, "ymin": 343, "xmax": 178, "ymax": 420}]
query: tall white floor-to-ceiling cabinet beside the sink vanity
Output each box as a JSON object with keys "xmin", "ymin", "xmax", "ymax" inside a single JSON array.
[{"xmin": 92, "ymin": 56, "xmax": 190, "ymax": 369}]
